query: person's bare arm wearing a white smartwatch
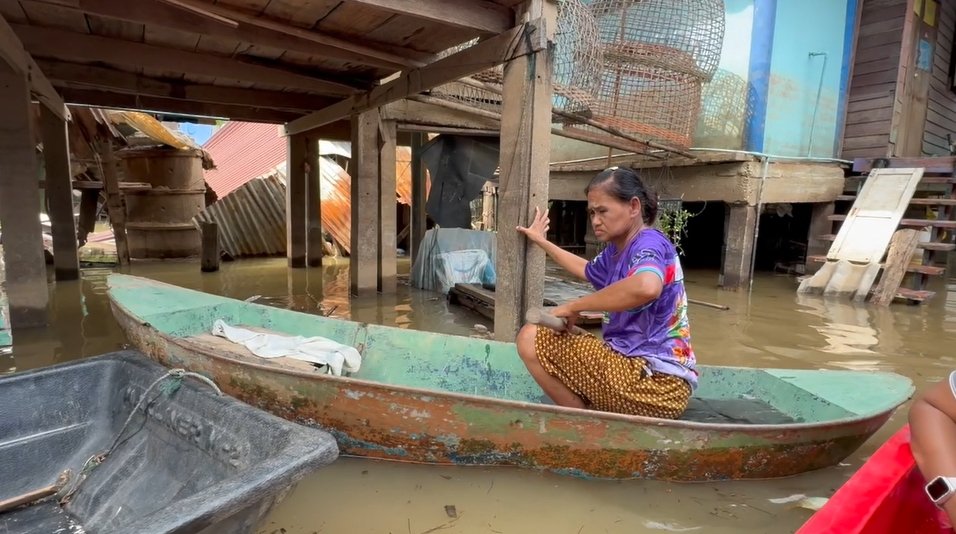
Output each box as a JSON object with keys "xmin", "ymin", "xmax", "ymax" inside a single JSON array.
[{"xmin": 909, "ymin": 371, "xmax": 956, "ymax": 525}]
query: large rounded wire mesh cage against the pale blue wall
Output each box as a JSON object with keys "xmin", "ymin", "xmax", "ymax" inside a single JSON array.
[{"xmin": 565, "ymin": 0, "xmax": 724, "ymax": 148}]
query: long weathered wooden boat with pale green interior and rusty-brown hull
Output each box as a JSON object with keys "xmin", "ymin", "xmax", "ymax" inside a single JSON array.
[{"xmin": 109, "ymin": 274, "xmax": 913, "ymax": 481}]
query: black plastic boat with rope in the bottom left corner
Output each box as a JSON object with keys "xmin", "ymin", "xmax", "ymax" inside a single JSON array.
[{"xmin": 0, "ymin": 351, "xmax": 338, "ymax": 534}]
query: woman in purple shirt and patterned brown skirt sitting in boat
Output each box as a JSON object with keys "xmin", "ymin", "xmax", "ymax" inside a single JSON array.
[{"xmin": 516, "ymin": 167, "xmax": 697, "ymax": 419}]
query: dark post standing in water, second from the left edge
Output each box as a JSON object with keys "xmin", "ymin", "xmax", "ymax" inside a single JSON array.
[{"xmin": 40, "ymin": 106, "xmax": 80, "ymax": 280}]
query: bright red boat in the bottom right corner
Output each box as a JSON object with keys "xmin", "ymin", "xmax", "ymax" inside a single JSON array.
[{"xmin": 797, "ymin": 425, "xmax": 953, "ymax": 534}]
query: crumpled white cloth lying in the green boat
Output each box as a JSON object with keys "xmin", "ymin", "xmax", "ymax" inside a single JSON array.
[{"xmin": 212, "ymin": 319, "xmax": 362, "ymax": 376}]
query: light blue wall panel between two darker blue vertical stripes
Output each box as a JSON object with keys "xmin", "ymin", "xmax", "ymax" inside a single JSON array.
[{"xmin": 751, "ymin": 0, "xmax": 855, "ymax": 157}]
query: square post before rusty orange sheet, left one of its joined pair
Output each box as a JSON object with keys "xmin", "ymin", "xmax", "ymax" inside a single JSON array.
[{"xmin": 349, "ymin": 109, "xmax": 381, "ymax": 296}]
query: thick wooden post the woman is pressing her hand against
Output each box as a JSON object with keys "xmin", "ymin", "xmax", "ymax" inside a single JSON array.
[{"xmin": 495, "ymin": 0, "xmax": 557, "ymax": 341}]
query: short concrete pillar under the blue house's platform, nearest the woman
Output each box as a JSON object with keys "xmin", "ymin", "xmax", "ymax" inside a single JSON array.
[{"xmin": 719, "ymin": 204, "xmax": 757, "ymax": 291}]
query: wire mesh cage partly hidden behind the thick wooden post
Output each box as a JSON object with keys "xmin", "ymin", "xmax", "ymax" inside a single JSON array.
[{"xmin": 431, "ymin": 0, "xmax": 601, "ymax": 113}]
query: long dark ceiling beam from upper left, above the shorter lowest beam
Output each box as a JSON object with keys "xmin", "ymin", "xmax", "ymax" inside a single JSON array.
[{"xmin": 12, "ymin": 24, "xmax": 355, "ymax": 95}]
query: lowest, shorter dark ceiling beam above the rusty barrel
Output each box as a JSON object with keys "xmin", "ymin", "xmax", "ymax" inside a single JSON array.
[{"xmin": 60, "ymin": 87, "xmax": 299, "ymax": 124}]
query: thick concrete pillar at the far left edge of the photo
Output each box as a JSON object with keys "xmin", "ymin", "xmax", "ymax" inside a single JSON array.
[{"xmin": 0, "ymin": 63, "xmax": 50, "ymax": 328}]
